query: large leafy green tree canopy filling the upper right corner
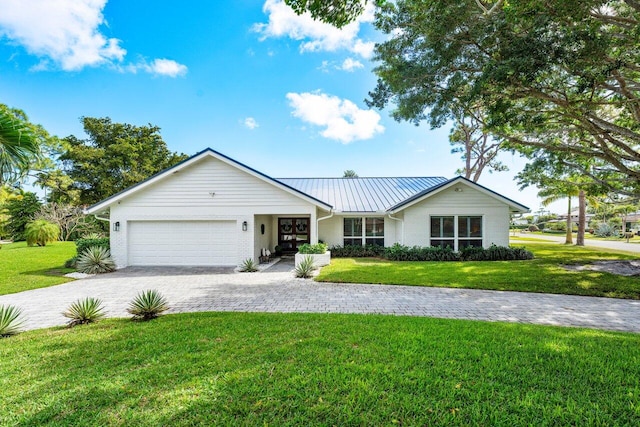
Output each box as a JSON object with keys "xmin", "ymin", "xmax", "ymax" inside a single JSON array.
[{"xmin": 368, "ymin": 0, "xmax": 640, "ymax": 192}]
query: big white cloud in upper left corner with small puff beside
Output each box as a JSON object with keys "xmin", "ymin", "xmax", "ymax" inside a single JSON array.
[{"xmin": 0, "ymin": 0, "xmax": 186, "ymax": 77}]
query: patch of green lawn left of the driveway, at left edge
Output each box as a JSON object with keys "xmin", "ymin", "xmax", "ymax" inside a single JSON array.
[{"xmin": 0, "ymin": 242, "xmax": 76, "ymax": 295}]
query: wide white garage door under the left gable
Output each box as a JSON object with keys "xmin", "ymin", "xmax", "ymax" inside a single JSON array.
[{"xmin": 128, "ymin": 221, "xmax": 237, "ymax": 266}]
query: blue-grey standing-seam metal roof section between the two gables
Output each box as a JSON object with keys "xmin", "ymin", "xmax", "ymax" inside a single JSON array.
[{"xmin": 276, "ymin": 176, "xmax": 447, "ymax": 212}]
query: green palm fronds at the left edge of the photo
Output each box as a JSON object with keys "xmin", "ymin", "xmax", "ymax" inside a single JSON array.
[{"xmin": 0, "ymin": 105, "xmax": 39, "ymax": 185}]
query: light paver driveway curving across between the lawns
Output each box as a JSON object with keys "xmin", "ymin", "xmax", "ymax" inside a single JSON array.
[{"xmin": 0, "ymin": 266, "xmax": 640, "ymax": 332}]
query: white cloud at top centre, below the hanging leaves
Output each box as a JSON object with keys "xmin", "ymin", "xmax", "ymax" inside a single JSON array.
[{"xmin": 254, "ymin": 0, "xmax": 374, "ymax": 58}]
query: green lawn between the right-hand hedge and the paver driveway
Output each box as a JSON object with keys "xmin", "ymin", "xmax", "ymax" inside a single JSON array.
[{"xmin": 316, "ymin": 243, "xmax": 640, "ymax": 299}]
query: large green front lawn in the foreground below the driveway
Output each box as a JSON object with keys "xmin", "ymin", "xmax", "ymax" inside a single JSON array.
[{"xmin": 0, "ymin": 313, "xmax": 640, "ymax": 426}]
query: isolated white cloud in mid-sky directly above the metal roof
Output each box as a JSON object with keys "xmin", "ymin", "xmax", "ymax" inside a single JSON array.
[{"xmin": 287, "ymin": 92, "xmax": 384, "ymax": 144}]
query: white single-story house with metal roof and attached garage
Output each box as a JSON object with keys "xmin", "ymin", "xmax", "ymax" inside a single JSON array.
[{"xmin": 86, "ymin": 148, "xmax": 529, "ymax": 268}]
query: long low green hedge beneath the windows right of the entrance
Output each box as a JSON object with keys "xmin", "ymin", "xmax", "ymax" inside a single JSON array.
[{"xmin": 330, "ymin": 243, "xmax": 533, "ymax": 261}]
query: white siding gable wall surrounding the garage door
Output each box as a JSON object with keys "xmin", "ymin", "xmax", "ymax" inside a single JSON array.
[{"xmin": 110, "ymin": 157, "xmax": 317, "ymax": 268}]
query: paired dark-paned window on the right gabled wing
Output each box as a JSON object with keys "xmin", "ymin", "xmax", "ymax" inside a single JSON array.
[{"xmin": 431, "ymin": 216, "xmax": 482, "ymax": 251}]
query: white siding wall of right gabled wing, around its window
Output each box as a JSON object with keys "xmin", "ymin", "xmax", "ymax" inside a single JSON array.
[{"xmin": 403, "ymin": 184, "xmax": 509, "ymax": 247}]
